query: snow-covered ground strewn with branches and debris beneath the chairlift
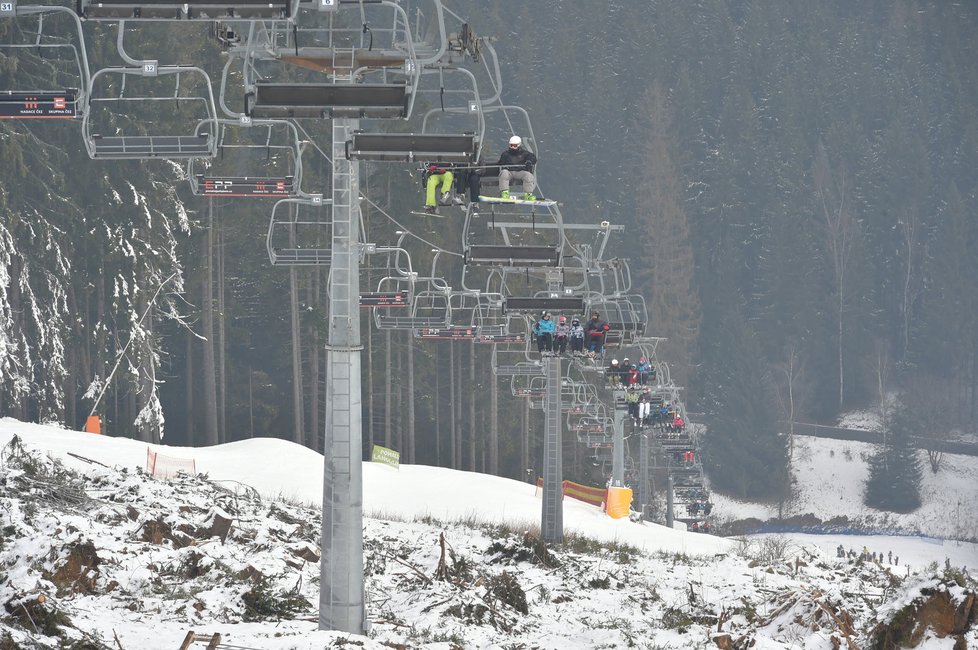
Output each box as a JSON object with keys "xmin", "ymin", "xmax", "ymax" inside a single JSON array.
[{"xmin": 0, "ymin": 419, "xmax": 978, "ymax": 650}]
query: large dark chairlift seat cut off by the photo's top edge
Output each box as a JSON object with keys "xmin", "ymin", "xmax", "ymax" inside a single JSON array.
[{"xmin": 78, "ymin": 0, "xmax": 293, "ymax": 20}]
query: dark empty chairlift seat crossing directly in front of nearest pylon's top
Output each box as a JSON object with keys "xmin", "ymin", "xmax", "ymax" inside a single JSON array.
[{"xmin": 245, "ymin": 82, "xmax": 410, "ymax": 119}]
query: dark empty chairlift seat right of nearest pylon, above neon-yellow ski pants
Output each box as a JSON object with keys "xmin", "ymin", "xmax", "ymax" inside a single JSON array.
[{"xmin": 346, "ymin": 133, "xmax": 477, "ymax": 164}]
